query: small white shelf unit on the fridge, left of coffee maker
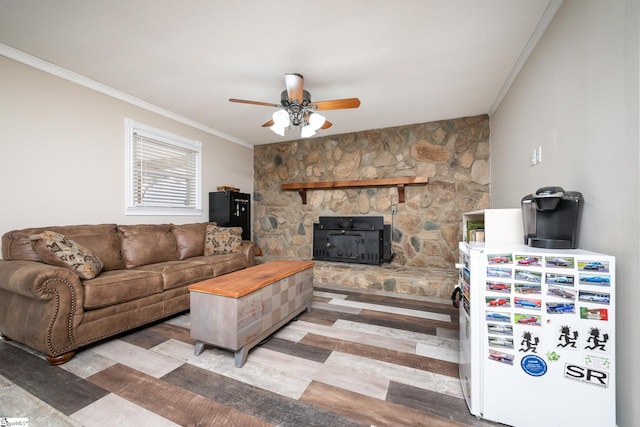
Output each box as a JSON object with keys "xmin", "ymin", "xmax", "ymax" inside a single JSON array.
[{"xmin": 462, "ymin": 208, "xmax": 524, "ymax": 243}]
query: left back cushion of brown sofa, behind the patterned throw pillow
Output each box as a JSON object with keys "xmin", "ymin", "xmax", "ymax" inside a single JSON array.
[{"xmin": 2, "ymin": 224, "xmax": 124, "ymax": 271}]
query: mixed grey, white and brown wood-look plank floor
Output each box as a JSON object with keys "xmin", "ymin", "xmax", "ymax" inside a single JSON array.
[{"xmin": 0, "ymin": 287, "xmax": 497, "ymax": 427}]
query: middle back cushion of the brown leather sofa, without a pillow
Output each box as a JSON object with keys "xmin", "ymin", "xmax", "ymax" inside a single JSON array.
[{"xmin": 118, "ymin": 224, "xmax": 178, "ymax": 268}]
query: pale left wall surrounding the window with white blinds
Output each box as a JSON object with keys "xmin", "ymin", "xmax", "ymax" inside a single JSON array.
[{"xmin": 0, "ymin": 55, "xmax": 253, "ymax": 241}]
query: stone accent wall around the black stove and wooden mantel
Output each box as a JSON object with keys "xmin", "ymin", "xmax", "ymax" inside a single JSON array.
[{"xmin": 253, "ymin": 115, "xmax": 490, "ymax": 269}]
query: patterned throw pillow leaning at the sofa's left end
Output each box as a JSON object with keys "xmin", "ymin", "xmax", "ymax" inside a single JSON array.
[{"xmin": 29, "ymin": 231, "xmax": 103, "ymax": 279}]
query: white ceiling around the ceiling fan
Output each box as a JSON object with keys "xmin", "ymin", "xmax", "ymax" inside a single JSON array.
[{"xmin": 0, "ymin": 0, "xmax": 558, "ymax": 145}]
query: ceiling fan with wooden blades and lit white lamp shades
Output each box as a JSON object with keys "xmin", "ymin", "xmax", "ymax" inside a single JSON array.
[{"xmin": 229, "ymin": 73, "xmax": 360, "ymax": 138}]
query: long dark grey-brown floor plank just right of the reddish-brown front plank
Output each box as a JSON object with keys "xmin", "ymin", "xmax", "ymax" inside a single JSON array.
[{"xmin": 162, "ymin": 365, "xmax": 368, "ymax": 427}]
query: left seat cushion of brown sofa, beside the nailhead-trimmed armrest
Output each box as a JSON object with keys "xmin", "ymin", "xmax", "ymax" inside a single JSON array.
[{"xmin": 82, "ymin": 270, "xmax": 162, "ymax": 309}]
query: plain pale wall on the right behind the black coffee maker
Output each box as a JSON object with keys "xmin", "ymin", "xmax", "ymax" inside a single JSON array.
[{"xmin": 491, "ymin": 0, "xmax": 640, "ymax": 426}]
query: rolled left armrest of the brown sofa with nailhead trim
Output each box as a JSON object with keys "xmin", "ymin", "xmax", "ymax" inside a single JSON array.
[{"xmin": 0, "ymin": 260, "xmax": 84, "ymax": 356}]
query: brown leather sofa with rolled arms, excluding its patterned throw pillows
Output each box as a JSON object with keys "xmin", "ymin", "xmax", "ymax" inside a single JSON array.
[{"xmin": 0, "ymin": 223, "xmax": 258, "ymax": 364}]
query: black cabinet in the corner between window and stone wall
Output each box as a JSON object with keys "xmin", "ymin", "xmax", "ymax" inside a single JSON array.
[{"xmin": 209, "ymin": 191, "xmax": 251, "ymax": 240}]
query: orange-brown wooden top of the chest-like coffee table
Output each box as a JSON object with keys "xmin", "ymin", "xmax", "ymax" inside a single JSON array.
[{"xmin": 189, "ymin": 259, "xmax": 314, "ymax": 298}]
